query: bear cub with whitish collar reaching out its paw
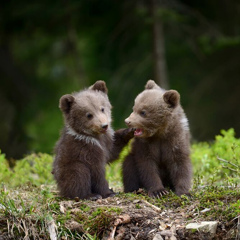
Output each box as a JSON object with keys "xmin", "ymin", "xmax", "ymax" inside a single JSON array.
[{"xmin": 52, "ymin": 81, "xmax": 133, "ymax": 200}]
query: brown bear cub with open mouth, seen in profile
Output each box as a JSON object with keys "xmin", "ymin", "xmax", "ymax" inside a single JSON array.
[{"xmin": 123, "ymin": 80, "xmax": 192, "ymax": 198}]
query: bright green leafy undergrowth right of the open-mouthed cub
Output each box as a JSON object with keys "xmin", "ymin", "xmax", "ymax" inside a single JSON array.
[{"xmin": 191, "ymin": 129, "xmax": 240, "ymax": 185}]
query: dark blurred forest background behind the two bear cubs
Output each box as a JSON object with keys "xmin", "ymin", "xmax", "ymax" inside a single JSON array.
[{"xmin": 0, "ymin": 0, "xmax": 240, "ymax": 158}]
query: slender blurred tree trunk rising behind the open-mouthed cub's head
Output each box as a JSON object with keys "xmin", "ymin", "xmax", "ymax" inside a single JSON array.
[{"xmin": 150, "ymin": 0, "xmax": 169, "ymax": 89}]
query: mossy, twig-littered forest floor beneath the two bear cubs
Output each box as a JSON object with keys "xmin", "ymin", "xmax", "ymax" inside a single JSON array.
[{"xmin": 0, "ymin": 185, "xmax": 240, "ymax": 240}]
